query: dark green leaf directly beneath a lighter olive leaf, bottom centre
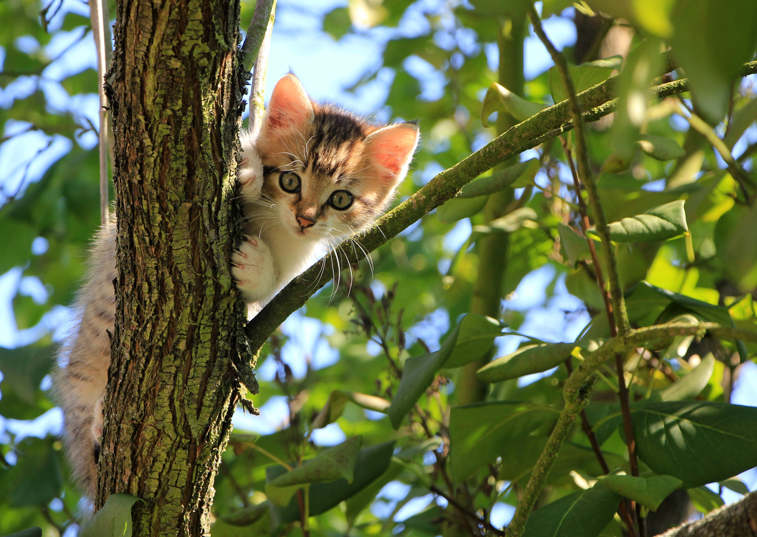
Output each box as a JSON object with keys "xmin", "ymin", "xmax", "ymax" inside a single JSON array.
[{"xmin": 274, "ymin": 441, "xmax": 395, "ymax": 524}]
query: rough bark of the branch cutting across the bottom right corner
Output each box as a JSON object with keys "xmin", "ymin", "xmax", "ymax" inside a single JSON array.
[{"xmin": 662, "ymin": 492, "xmax": 757, "ymax": 537}]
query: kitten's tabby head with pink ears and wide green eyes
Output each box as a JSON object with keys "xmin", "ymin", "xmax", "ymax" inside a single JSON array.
[{"xmin": 256, "ymin": 74, "xmax": 418, "ymax": 241}]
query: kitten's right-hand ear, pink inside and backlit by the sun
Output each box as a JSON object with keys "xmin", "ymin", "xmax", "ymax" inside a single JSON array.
[{"xmin": 365, "ymin": 123, "xmax": 418, "ymax": 186}]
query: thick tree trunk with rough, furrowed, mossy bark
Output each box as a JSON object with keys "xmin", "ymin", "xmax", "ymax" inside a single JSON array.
[{"xmin": 96, "ymin": 0, "xmax": 243, "ymax": 536}]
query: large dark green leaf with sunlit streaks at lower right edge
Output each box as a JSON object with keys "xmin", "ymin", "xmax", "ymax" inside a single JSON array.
[{"xmin": 632, "ymin": 401, "xmax": 757, "ymax": 489}]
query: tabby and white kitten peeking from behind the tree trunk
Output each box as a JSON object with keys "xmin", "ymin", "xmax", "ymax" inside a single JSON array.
[{"xmin": 55, "ymin": 75, "xmax": 418, "ymax": 498}]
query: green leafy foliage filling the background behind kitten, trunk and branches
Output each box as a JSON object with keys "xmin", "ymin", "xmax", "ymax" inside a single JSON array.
[{"xmin": 0, "ymin": 0, "xmax": 757, "ymax": 537}]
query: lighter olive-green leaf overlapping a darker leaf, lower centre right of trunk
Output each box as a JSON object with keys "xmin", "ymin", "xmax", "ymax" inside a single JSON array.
[{"xmin": 265, "ymin": 436, "xmax": 363, "ymax": 506}]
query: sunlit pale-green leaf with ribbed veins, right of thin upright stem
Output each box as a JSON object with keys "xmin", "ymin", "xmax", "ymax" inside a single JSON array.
[{"xmin": 608, "ymin": 200, "xmax": 689, "ymax": 242}]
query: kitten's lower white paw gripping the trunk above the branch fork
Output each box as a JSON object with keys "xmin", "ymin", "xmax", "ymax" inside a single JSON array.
[{"xmin": 231, "ymin": 237, "xmax": 276, "ymax": 303}]
